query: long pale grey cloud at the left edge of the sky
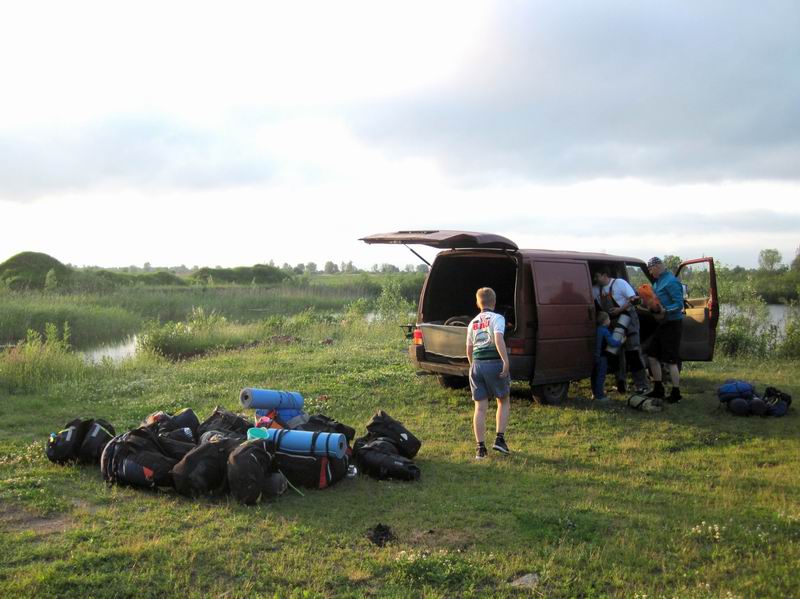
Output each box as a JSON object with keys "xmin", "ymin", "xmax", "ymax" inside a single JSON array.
[{"xmin": 0, "ymin": 118, "xmax": 273, "ymax": 201}]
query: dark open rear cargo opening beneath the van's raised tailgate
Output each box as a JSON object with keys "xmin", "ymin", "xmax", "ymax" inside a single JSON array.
[{"xmin": 421, "ymin": 252, "xmax": 517, "ymax": 328}]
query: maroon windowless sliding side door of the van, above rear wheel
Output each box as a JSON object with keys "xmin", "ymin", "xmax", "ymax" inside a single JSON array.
[{"xmin": 531, "ymin": 260, "xmax": 595, "ymax": 385}]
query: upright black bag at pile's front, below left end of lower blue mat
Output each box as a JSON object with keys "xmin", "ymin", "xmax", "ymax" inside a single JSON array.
[{"xmin": 228, "ymin": 439, "xmax": 287, "ymax": 505}]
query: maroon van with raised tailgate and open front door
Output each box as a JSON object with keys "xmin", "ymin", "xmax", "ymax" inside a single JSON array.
[{"xmin": 362, "ymin": 231, "xmax": 719, "ymax": 403}]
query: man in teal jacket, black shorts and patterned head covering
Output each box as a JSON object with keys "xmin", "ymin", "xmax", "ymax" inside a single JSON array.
[{"xmin": 647, "ymin": 256, "xmax": 683, "ymax": 403}]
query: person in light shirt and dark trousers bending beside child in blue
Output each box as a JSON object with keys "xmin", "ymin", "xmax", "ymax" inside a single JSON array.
[{"xmin": 595, "ymin": 267, "xmax": 647, "ymax": 393}]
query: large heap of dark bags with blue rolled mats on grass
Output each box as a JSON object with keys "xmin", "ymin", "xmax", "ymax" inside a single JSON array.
[{"xmin": 45, "ymin": 389, "xmax": 421, "ymax": 504}]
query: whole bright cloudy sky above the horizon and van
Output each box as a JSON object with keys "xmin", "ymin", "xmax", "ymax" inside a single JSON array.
[{"xmin": 0, "ymin": 0, "xmax": 800, "ymax": 268}]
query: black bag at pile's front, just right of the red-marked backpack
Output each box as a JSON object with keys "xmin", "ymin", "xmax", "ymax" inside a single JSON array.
[{"xmin": 171, "ymin": 439, "xmax": 239, "ymax": 497}]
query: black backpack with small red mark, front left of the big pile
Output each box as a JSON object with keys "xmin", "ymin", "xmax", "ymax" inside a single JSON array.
[{"xmin": 100, "ymin": 427, "xmax": 177, "ymax": 489}]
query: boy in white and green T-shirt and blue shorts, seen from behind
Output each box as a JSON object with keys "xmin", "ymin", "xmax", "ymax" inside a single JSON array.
[{"xmin": 467, "ymin": 287, "xmax": 511, "ymax": 460}]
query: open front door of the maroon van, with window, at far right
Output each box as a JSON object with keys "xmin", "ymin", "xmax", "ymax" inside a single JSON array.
[{"xmin": 675, "ymin": 258, "xmax": 719, "ymax": 362}]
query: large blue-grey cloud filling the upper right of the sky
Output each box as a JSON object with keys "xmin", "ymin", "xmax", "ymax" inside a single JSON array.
[{"xmin": 354, "ymin": 0, "xmax": 800, "ymax": 184}]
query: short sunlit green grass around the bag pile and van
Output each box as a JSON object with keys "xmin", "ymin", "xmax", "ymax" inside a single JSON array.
[{"xmin": 0, "ymin": 319, "xmax": 800, "ymax": 597}]
